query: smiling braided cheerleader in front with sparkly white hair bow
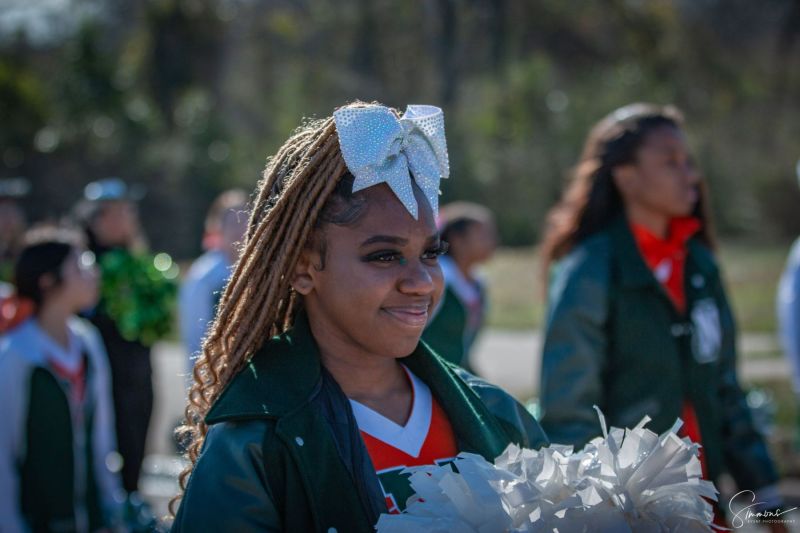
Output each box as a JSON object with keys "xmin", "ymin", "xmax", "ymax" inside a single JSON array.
[{"xmin": 174, "ymin": 105, "xmax": 546, "ymax": 532}]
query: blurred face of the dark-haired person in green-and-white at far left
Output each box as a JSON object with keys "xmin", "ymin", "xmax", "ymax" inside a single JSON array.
[{"xmin": 45, "ymin": 249, "xmax": 99, "ymax": 313}]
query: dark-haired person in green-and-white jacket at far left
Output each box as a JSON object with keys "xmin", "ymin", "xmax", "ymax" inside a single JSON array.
[{"xmin": 0, "ymin": 230, "xmax": 124, "ymax": 532}]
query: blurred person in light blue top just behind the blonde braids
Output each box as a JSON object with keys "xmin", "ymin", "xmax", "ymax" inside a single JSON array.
[{"xmin": 178, "ymin": 189, "xmax": 248, "ymax": 377}]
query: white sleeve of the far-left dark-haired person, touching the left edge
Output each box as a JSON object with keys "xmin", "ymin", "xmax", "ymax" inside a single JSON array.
[{"xmin": 0, "ymin": 346, "xmax": 30, "ymax": 533}]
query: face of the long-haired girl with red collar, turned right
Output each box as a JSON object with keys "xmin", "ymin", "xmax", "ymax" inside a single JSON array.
[{"xmin": 615, "ymin": 126, "xmax": 700, "ymax": 218}]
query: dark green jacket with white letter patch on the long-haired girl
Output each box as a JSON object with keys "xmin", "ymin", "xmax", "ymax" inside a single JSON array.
[{"xmin": 541, "ymin": 217, "xmax": 777, "ymax": 490}]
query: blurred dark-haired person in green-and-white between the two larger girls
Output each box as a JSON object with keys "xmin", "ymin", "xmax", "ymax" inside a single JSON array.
[{"xmin": 422, "ymin": 202, "xmax": 497, "ymax": 372}]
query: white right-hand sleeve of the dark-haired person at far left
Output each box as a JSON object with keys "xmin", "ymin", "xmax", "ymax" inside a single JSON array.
[{"xmin": 83, "ymin": 323, "xmax": 125, "ymax": 516}]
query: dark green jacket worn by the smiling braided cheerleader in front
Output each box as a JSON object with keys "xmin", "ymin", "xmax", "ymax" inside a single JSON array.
[{"xmin": 173, "ymin": 314, "xmax": 547, "ymax": 532}]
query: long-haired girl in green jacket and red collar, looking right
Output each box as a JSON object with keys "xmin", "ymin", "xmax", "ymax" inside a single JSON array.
[{"xmin": 541, "ymin": 104, "xmax": 781, "ymax": 530}]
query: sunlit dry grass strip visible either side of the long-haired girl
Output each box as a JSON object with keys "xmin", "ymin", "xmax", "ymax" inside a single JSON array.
[{"xmin": 484, "ymin": 242, "xmax": 789, "ymax": 333}]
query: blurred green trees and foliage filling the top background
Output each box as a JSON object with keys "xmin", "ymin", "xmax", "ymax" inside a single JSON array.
[{"xmin": 0, "ymin": 0, "xmax": 800, "ymax": 257}]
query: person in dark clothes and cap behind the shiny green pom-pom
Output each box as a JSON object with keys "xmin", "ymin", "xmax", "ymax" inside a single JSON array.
[{"xmin": 77, "ymin": 178, "xmax": 153, "ymax": 492}]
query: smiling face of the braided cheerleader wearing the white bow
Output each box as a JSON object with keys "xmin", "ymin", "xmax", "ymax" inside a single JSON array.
[{"xmin": 293, "ymin": 185, "xmax": 443, "ymax": 358}]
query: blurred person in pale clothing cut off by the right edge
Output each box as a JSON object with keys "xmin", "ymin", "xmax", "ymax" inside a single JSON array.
[{"xmin": 777, "ymin": 157, "xmax": 800, "ymax": 447}]
